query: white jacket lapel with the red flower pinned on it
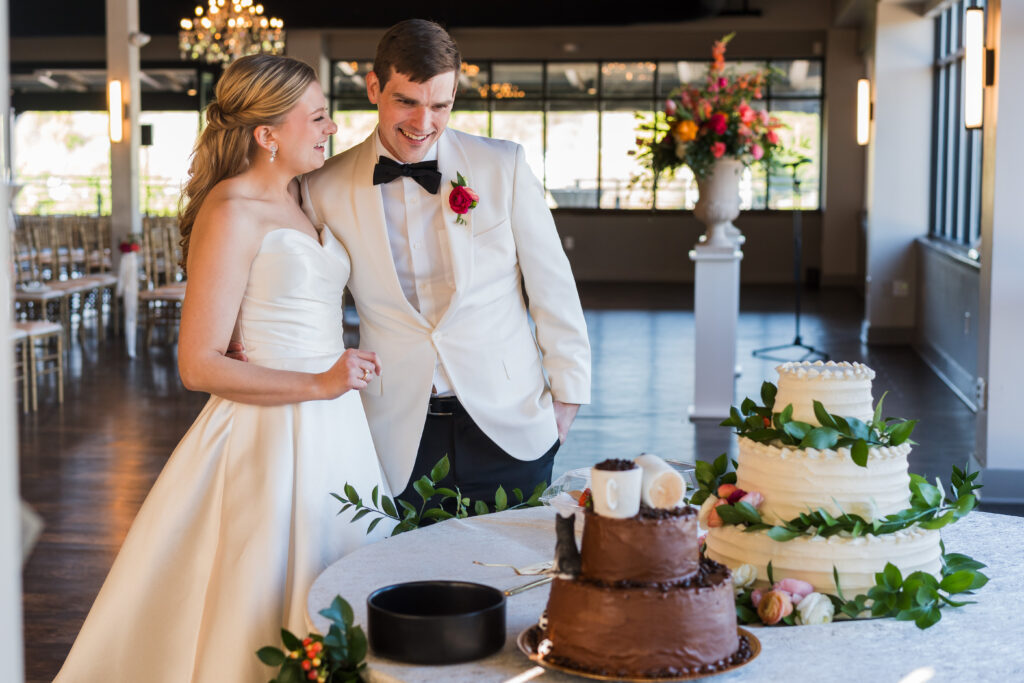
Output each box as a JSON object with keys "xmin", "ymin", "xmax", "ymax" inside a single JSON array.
[{"xmin": 437, "ymin": 130, "xmax": 474, "ymax": 326}]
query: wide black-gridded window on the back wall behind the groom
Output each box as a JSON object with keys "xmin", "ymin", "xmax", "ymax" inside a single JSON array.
[{"xmin": 332, "ymin": 59, "xmax": 823, "ymax": 210}]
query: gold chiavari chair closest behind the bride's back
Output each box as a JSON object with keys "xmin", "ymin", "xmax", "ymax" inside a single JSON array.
[{"xmin": 138, "ymin": 216, "xmax": 185, "ymax": 346}]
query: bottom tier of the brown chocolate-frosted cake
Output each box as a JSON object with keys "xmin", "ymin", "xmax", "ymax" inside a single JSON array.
[{"xmin": 546, "ymin": 561, "xmax": 739, "ymax": 677}]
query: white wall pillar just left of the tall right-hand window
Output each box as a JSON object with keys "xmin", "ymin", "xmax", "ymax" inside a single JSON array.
[{"xmin": 862, "ymin": 3, "xmax": 935, "ymax": 344}]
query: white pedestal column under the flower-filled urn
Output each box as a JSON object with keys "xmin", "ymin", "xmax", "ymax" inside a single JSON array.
[{"xmin": 689, "ymin": 244, "xmax": 743, "ymax": 420}]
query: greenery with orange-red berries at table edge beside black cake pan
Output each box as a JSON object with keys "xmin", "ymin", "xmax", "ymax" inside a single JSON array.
[{"xmin": 256, "ymin": 595, "xmax": 367, "ymax": 683}]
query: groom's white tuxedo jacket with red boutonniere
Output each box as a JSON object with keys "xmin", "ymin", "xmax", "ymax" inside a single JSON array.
[{"xmin": 302, "ymin": 129, "xmax": 590, "ymax": 493}]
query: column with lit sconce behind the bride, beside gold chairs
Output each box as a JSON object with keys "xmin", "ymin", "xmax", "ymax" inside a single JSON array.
[{"xmin": 106, "ymin": 0, "xmax": 142, "ymax": 246}]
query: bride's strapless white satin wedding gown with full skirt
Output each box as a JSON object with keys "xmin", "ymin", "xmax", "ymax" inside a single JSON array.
[{"xmin": 56, "ymin": 228, "xmax": 387, "ymax": 683}]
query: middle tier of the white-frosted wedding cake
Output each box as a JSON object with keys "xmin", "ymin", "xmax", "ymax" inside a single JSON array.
[{"xmin": 736, "ymin": 437, "xmax": 910, "ymax": 524}]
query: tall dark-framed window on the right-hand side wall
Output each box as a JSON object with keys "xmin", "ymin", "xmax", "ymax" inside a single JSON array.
[{"xmin": 931, "ymin": 0, "xmax": 984, "ymax": 249}]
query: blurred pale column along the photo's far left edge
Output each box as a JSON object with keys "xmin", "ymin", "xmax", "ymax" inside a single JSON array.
[{"xmin": 0, "ymin": 0, "xmax": 28, "ymax": 681}]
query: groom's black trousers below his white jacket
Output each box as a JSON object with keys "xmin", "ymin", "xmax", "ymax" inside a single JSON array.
[{"xmin": 397, "ymin": 396, "xmax": 560, "ymax": 514}]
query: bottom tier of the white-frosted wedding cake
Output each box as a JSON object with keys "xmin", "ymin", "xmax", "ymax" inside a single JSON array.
[{"xmin": 707, "ymin": 525, "xmax": 942, "ymax": 599}]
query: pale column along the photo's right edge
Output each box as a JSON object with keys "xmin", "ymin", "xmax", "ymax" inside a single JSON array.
[{"xmin": 977, "ymin": 0, "xmax": 1024, "ymax": 504}]
